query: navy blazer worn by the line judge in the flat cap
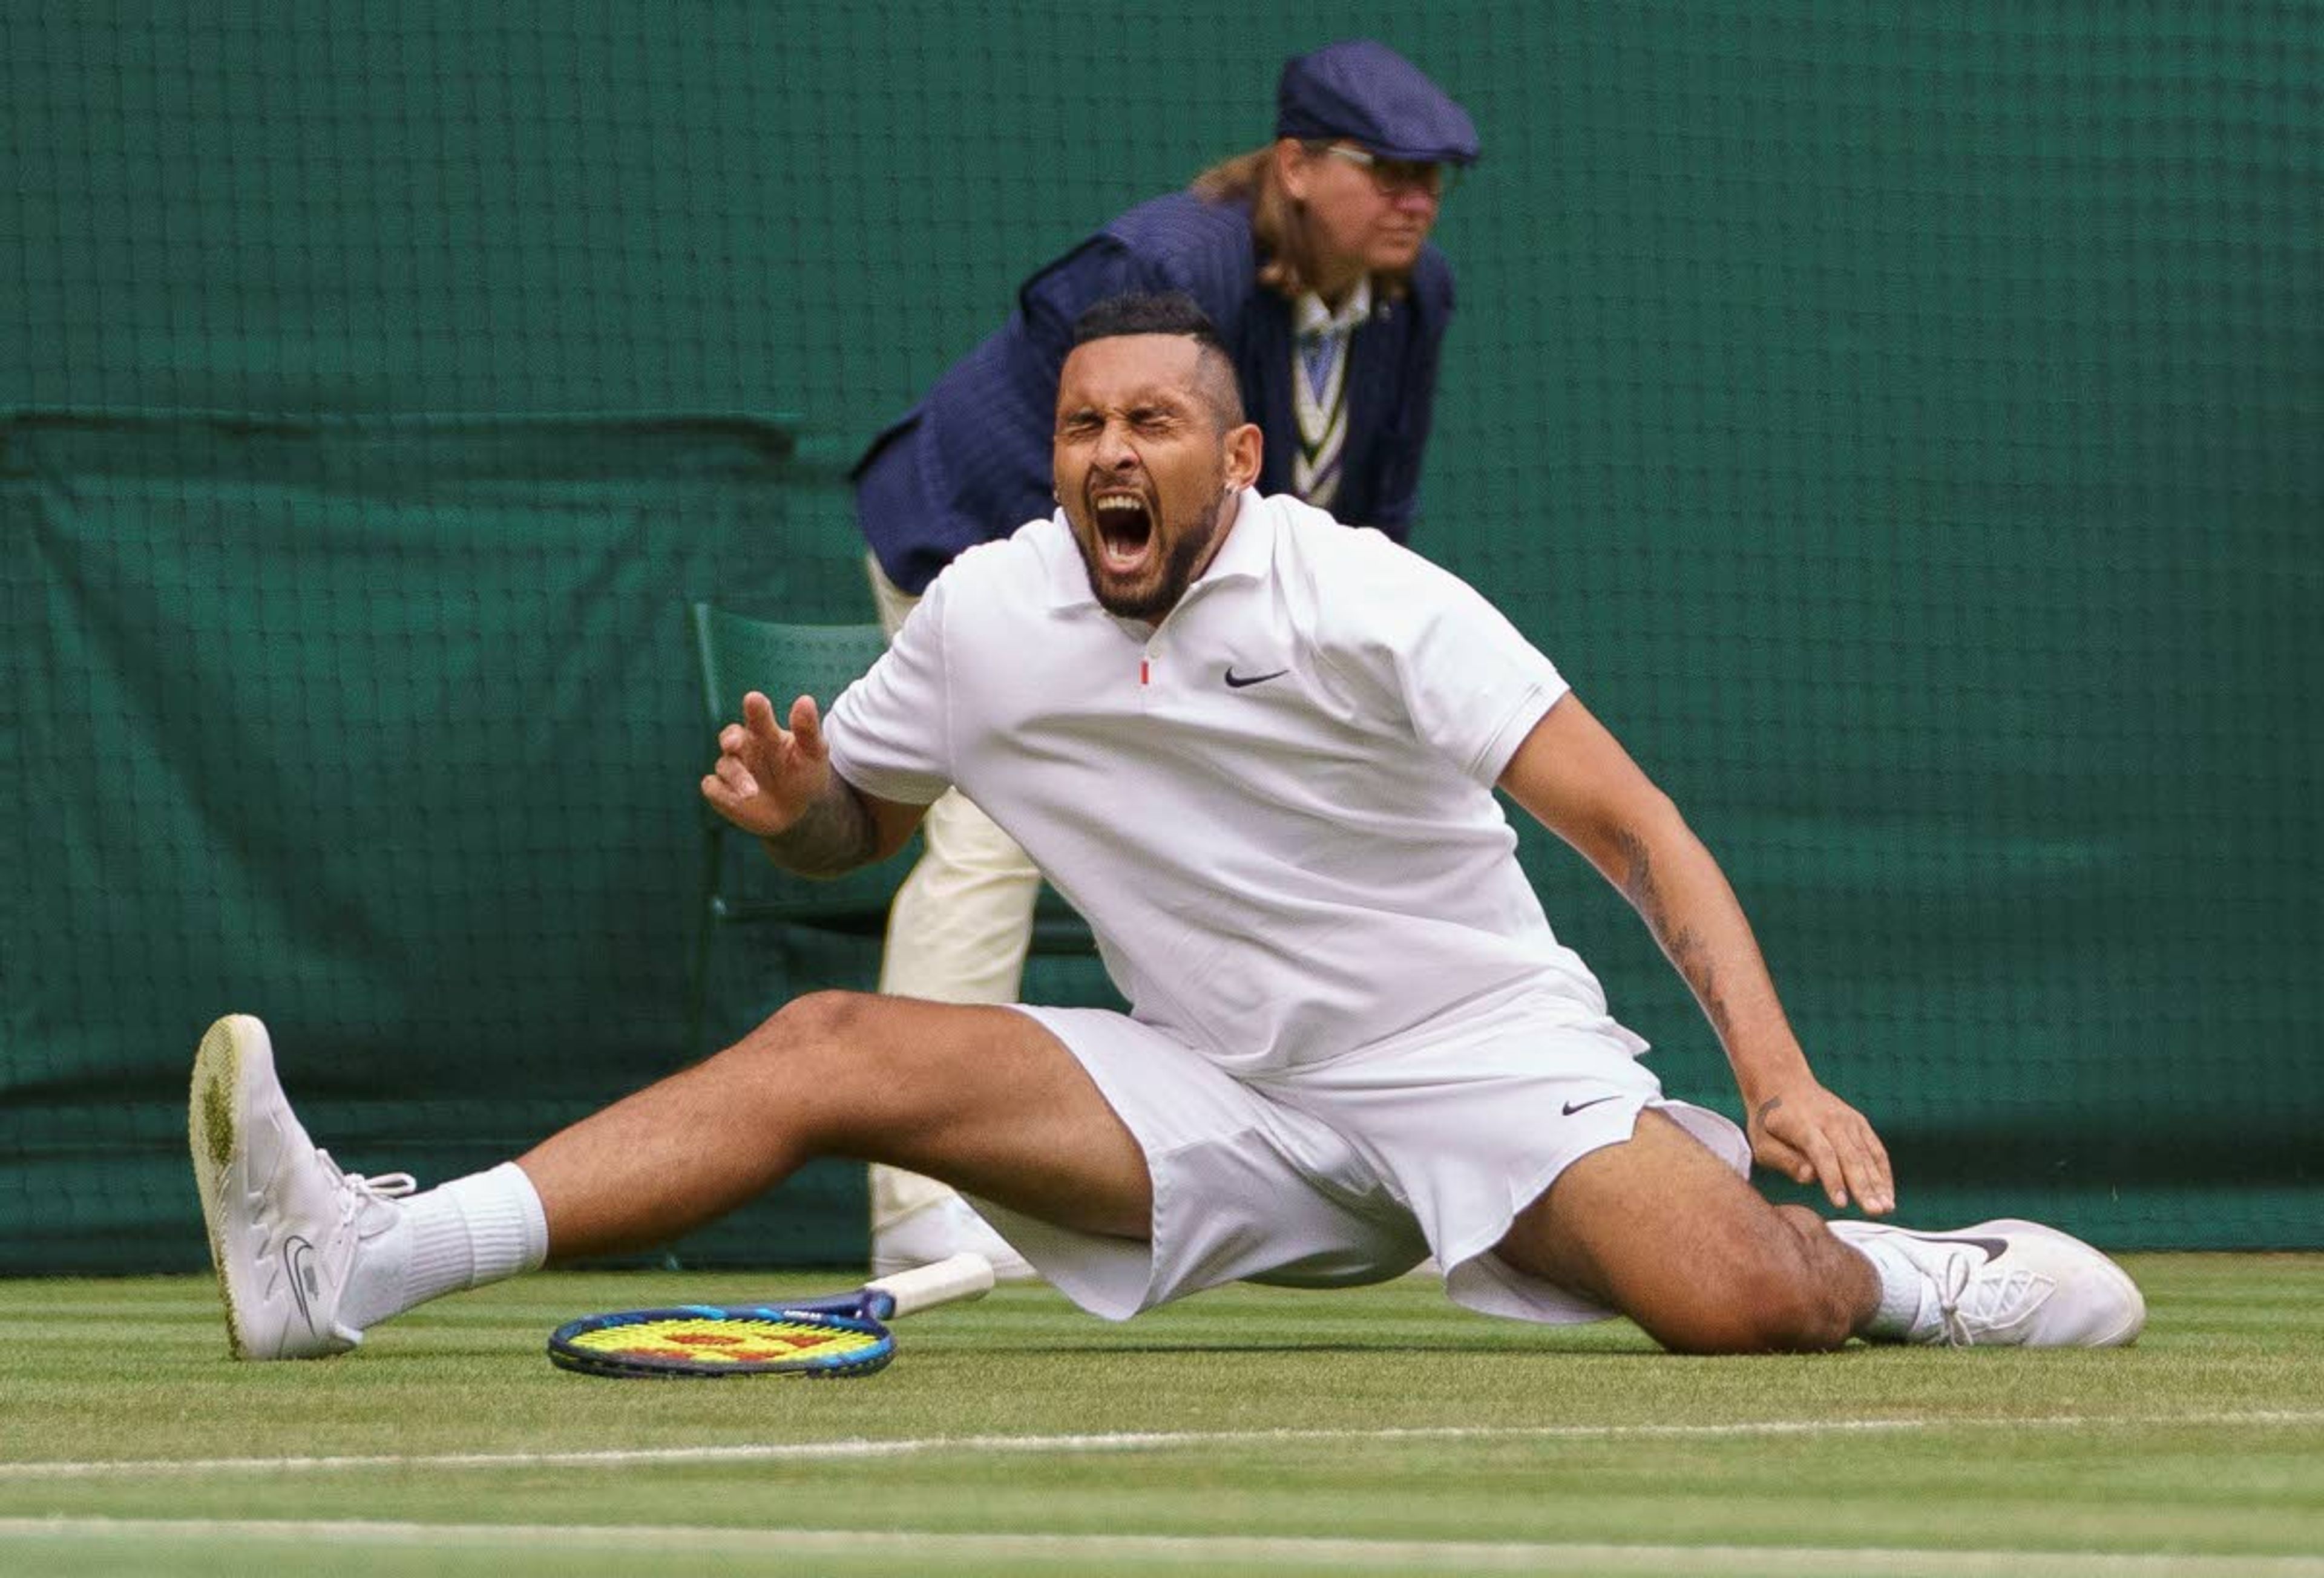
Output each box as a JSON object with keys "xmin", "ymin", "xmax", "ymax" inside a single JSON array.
[{"xmin": 853, "ymin": 193, "xmax": 1452, "ymax": 592}]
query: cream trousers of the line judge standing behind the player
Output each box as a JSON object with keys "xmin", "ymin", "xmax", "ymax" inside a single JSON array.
[{"xmin": 867, "ymin": 555, "xmax": 1041, "ymax": 1234}]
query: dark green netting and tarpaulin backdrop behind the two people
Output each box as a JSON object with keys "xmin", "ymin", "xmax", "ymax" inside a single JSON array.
[{"xmin": 0, "ymin": 0, "xmax": 2324, "ymax": 1271}]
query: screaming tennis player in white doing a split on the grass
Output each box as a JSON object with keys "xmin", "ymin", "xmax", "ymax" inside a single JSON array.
[{"xmin": 191, "ymin": 298, "xmax": 2145, "ymax": 1360}]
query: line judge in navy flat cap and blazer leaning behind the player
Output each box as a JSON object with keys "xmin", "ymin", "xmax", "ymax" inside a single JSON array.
[{"xmin": 855, "ymin": 39, "xmax": 1480, "ymax": 1278}]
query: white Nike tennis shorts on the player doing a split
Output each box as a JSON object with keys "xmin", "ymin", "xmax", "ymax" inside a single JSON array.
[{"xmin": 974, "ymin": 995, "xmax": 1750, "ymax": 1322}]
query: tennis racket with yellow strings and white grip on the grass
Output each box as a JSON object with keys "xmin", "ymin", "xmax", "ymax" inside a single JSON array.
[{"xmin": 548, "ymin": 1255, "xmax": 993, "ymax": 1378}]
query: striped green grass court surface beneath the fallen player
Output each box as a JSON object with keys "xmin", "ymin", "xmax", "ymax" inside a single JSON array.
[{"xmin": 0, "ymin": 1255, "xmax": 2324, "ymax": 1578}]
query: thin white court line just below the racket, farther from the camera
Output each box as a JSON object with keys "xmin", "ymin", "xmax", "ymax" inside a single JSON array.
[{"xmin": 0, "ymin": 1409, "xmax": 2324, "ymax": 1483}]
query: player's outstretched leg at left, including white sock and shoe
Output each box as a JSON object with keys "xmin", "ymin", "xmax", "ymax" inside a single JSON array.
[{"xmin": 188, "ymin": 992, "xmax": 1153, "ymax": 1360}]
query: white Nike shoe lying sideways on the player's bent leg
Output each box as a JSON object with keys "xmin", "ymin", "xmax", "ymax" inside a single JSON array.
[{"xmin": 1827, "ymin": 1218, "xmax": 2147, "ymax": 1348}]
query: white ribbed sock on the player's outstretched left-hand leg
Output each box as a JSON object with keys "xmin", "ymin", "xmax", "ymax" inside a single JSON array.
[{"xmin": 340, "ymin": 1162, "xmax": 548, "ymax": 1332}]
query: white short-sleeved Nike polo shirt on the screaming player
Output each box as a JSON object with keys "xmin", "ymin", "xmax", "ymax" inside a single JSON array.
[{"xmin": 827, "ymin": 493, "xmax": 1606, "ymax": 1076}]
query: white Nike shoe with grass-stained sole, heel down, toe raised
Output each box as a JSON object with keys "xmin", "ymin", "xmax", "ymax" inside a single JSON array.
[{"xmin": 186, "ymin": 1013, "xmax": 414, "ymax": 1360}]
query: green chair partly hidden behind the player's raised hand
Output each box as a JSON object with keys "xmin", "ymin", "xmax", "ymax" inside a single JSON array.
[{"xmin": 686, "ymin": 602, "xmax": 1097, "ymax": 1055}]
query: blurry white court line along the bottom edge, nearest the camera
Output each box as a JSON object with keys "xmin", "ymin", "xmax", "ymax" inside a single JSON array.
[{"xmin": 0, "ymin": 1517, "xmax": 2324, "ymax": 1578}]
